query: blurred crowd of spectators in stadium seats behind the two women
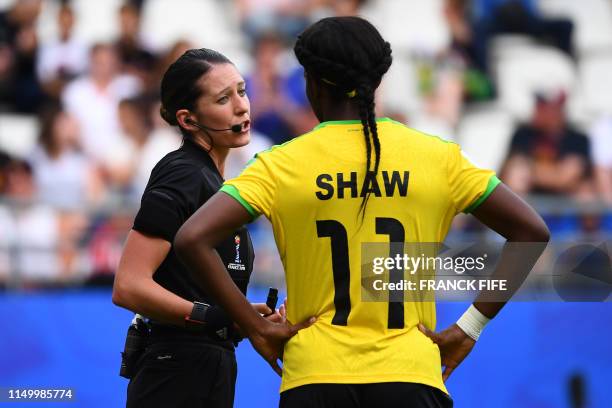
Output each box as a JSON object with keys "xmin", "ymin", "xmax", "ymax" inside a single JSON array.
[{"xmin": 0, "ymin": 0, "xmax": 612, "ymax": 289}]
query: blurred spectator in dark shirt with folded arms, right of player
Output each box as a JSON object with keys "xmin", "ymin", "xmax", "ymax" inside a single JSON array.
[{"xmin": 502, "ymin": 92, "xmax": 592, "ymax": 197}]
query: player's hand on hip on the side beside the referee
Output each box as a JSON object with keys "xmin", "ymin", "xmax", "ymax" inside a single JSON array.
[{"xmin": 249, "ymin": 317, "xmax": 317, "ymax": 376}]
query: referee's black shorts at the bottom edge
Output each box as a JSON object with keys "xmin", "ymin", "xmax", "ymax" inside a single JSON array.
[{"xmin": 126, "ymin": 342, "xmax": 237, "ymax": 408}]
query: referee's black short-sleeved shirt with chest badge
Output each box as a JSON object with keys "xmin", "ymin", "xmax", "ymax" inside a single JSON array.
[{"xmin": 133, "ymin": 139, "xmax": 254, "ymax": 312}]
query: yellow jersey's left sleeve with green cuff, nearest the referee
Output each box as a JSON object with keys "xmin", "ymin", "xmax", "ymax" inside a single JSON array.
[{"xmin": 220, "ymin": 154, "xmax": 276, "ymax": 219}]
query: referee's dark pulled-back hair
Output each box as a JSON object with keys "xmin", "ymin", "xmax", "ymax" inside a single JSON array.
[{"xmin": 159, "ymin": 48, "xmax": 232, "ymax": 137}]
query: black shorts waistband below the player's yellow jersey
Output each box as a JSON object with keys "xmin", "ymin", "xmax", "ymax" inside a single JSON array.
[{"xmin": 279, "ymin": 382, "xmax": 453, "ymax": 408}]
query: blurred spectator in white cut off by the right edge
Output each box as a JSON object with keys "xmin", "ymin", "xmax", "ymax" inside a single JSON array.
[{"xmin": 591, "ymin": 116, "xmax": 612, "ymax": 205}]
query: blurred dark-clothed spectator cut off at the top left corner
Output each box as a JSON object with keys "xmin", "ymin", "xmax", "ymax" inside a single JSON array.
[{"xmin": 0, "ymin": 0, "xmax": 43, "ymax": 113}]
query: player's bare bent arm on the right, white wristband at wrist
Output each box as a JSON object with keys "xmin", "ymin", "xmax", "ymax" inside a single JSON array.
[{"xmin": 419, "ymin": 184, "xmax": 550, "ymax": 381}]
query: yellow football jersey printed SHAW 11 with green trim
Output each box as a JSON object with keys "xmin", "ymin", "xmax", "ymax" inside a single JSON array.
[{"xmin": 221, "ymin": 118, "xmax": 499, "ymax": 392}]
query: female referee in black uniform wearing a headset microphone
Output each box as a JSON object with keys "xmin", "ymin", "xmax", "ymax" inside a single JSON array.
[{"xmin": 113, "ymin": 48, "xmax": 280, "ymax": 408}]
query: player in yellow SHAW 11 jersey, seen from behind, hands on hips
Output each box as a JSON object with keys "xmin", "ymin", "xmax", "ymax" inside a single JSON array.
[{"xmin": 176, "ymin": 17, "xmax": 549, "ymax": 407}]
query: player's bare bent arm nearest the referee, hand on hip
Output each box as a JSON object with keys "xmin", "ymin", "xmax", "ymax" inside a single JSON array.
[{"xmin": 174, "ymin": 192, "xmax": 314, "ymax": 375}]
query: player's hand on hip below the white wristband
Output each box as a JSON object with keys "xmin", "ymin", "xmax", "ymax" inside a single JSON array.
[{"xmin": 419, "ymin": 324, "xmax": 476, "ymax": 382}]
